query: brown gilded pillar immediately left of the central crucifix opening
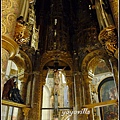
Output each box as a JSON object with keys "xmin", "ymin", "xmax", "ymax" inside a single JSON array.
[{"xmin": 28, "ymin": 74, "xmax": 44, "ymax": 120}]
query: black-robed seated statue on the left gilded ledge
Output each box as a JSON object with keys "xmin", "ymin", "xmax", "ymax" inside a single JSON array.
[{"xmin": 9, "ymin": 82, "xmax": 24, "ymax": 104}]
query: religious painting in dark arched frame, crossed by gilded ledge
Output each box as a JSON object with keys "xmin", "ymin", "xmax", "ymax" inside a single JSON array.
[{"xmin": 98, "ymin": 77, "xmax": 118, "ymax": 120}]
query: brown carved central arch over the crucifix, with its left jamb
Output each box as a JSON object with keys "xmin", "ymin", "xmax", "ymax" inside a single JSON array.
[{"xmin": 30, "ymin": 51, "xmax": 73, "ymax": 119}]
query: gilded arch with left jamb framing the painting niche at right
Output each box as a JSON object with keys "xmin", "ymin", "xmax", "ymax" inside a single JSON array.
[{"xmin": 81, "ymin": 49, "xmax": 110, "ymax": 107}]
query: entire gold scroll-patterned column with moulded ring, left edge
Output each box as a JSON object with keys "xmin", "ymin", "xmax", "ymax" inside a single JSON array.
[{"xmin": 2, "ymin": 0, "xmax": 20, "ymax": 93}]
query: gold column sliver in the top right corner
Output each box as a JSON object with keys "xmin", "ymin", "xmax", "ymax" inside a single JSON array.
[{"xmin": 109, "ymin": 0, "xmax": 118, "ymax": 30}]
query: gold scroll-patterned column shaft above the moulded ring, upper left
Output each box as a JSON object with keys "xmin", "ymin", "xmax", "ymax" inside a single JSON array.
[{"xmin": 2, "ymin": 0, "xmax": 20, "ymax": 38}]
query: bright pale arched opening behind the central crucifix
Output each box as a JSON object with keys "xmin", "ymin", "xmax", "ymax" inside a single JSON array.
[{"xmin": 42, "ymin": 69, "xmax": 69, "ymax": 120}]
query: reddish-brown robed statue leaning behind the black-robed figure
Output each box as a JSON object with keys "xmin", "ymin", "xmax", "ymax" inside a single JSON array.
[{"xmin": 2, "ymin": 76, "xmax": 16, "ymax": 100}]
